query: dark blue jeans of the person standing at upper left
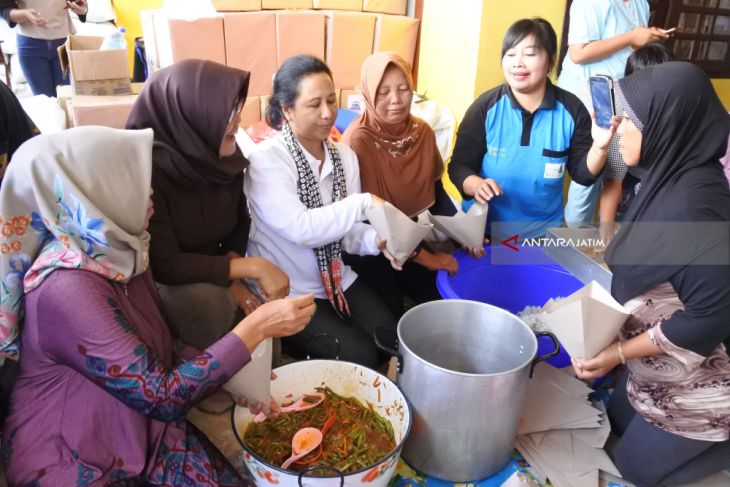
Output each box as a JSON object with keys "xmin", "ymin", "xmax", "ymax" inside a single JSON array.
[{"xmin": 18, "ymin": 34, "xmax": 69, "ymax": 97}]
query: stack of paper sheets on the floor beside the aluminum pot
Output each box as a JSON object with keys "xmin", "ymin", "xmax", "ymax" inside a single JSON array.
[{"xmin": 516, "ymin": 363, "xmax": 620, "ymax": 487}]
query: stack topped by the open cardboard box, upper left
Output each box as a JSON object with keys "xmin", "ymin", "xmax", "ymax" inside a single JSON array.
[{"xmin": 57, "ymin": 35, "xmax": 140, "ymax": 128}]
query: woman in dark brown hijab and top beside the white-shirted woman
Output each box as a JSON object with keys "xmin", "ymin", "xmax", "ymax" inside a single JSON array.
[{"xmin": 126, "ymin": 59, "xmax": 289, "ymax": 358}]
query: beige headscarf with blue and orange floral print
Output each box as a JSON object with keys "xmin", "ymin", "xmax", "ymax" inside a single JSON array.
[{"xmin": 0, "ymin": 127, "xmax": 152, "ymax": 359}]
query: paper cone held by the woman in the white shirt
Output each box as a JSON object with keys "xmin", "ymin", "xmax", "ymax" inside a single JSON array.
[{"xmin": 365, "ymin": 202, "xmax": 431, "ymax": 265}]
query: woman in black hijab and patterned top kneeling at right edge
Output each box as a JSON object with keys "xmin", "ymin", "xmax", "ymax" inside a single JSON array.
[{"xmin": 573, "ymin": 62, "xmax": 730, "ymax": 487}]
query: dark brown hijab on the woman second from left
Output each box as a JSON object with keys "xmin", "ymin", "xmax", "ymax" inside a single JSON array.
[{"xmin": 126, "ymin": 59, "xmax": 250, "ymax": 187}]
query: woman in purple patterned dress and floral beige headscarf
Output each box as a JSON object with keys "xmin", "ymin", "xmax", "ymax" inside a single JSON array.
[{"xmin": 0, "ymin": 127, "xmax": 314, "ymax": 486}]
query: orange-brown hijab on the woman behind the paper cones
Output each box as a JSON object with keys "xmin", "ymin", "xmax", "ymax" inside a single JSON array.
[{"xmin": 342, "ymin": 52, "xmax": 444, "ymax": 216}]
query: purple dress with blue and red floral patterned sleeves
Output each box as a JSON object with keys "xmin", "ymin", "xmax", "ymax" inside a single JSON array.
[{"xmin": 2, "ymin": 269, "xmax": 249, "ymax": 486}]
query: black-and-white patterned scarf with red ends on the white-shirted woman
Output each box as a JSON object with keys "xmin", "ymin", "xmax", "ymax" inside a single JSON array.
[{"xmin": 282, "ymin": 123, "xmax": 350, "ymax": 317}]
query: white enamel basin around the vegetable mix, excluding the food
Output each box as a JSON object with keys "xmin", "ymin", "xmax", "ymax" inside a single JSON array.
[{"xmin": 232, "ymin": 360, "xmax": 411, "ymax": 487}]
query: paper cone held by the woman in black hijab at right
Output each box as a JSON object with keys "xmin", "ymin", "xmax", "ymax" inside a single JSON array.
[{"xmin": 543, "ymin": 281, "xmax": 629, "ymax": 358}]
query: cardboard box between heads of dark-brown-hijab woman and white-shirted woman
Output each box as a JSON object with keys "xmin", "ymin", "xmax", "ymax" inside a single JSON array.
[{"xmin": 223, "ymin": 11, "xmax": 277, "ymax": 96}]
